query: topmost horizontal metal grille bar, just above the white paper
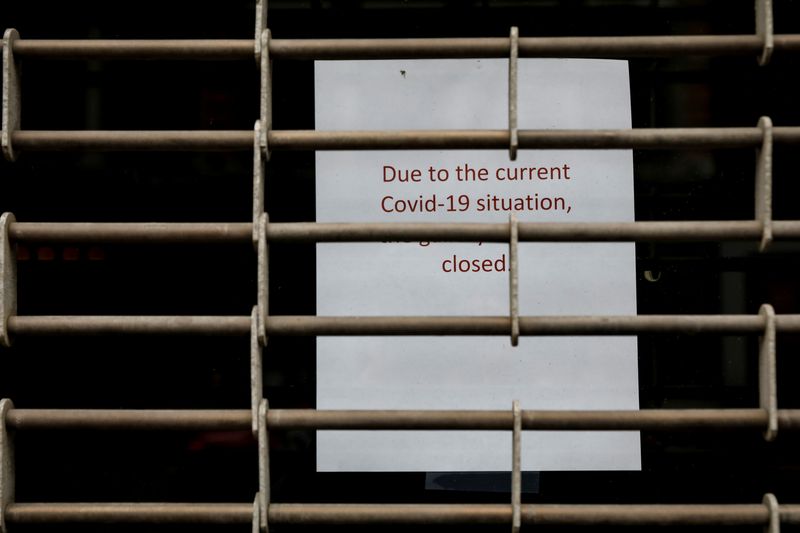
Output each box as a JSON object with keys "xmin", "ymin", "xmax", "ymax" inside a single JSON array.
[{"xmin": 4, "ymin": 34, "xmax": 800, "ymax": 60}]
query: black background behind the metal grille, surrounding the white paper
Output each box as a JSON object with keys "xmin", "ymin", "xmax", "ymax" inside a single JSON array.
[{"xmin": 0, "ymin": 0, "xmax": 800, "ymax": 531}]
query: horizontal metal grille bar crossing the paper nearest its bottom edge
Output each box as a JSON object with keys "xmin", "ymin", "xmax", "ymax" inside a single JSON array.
[{"xmin": 6, "ymin": 409, "xmax": 800, "ymax": 431}]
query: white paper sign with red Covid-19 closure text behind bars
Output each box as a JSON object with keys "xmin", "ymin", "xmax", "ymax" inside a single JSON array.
[{"xmin": 315, "ymin": 59, "xmax": 640, "ymax": 472}]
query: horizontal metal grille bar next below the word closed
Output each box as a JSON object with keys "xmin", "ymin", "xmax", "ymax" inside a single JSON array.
[{"xmin": 8, "ymin": 314, "xmax": 800, "ymax": 336}]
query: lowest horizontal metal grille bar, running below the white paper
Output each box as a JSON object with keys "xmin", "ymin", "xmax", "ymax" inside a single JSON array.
[{"xmin": 6, "ymin": 503, "xmax": 800, "ymax": 526}]
